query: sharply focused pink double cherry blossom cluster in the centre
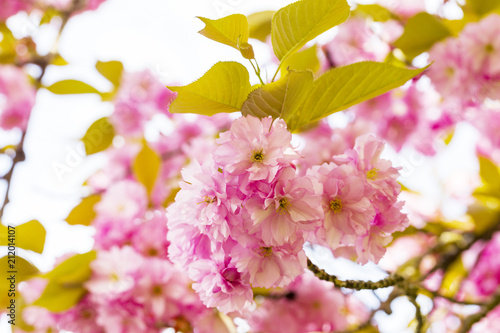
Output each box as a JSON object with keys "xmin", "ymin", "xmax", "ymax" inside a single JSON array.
[{"xmin": 167, "ymin": 116, "xmax": 408, "ymax": 312}]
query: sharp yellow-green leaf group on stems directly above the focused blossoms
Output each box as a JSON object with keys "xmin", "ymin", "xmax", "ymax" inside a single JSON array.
[{"xmin": 168, "ymin": 0, "xmax": 425, "ymax": 132}]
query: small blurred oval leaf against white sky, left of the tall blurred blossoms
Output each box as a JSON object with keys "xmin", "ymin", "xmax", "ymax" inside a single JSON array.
[{"xmin": 82, "ymin": 117, "xmax": 115, "ymax": 155}]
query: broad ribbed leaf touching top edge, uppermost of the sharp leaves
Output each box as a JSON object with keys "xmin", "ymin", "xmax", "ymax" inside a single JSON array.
[{"xmin": 271, "ymin": 0, "xmax": 350, "ymax": 61}]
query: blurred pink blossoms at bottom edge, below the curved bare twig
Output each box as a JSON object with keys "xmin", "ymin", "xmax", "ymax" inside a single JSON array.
[{"xmin": 243, "ymin": 271, "xmax": 369, "ymax": 333}]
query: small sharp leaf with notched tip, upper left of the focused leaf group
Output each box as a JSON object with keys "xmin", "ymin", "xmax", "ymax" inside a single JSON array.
[{"xmin": 198, "ymin": 14, "xmax": 249, "ymax": 49}]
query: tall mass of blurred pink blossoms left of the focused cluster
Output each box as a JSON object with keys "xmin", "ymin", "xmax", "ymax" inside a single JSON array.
[{"xmin": 16, "ymin": 72, "xmax": 238, "ymax": 333}]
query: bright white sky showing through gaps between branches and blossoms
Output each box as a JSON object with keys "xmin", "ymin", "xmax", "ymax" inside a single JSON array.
[{"xmin": 0, "ymin": 0, "xmax": 477, "ymax": 332}]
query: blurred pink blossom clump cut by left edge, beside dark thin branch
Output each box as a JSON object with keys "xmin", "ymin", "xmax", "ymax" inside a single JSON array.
[{"xmin": 0, "ymin": 65, "xmax": 36, "ymax": 131}]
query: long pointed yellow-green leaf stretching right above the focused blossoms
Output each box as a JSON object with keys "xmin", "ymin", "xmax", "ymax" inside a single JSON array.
[{"xmin": 291, "ymin": 61, "xmax": 427, "ymax": 130}]
